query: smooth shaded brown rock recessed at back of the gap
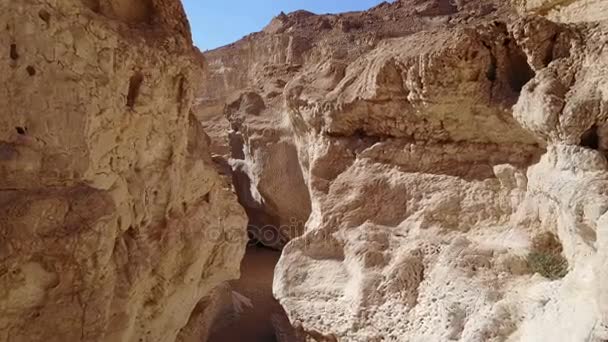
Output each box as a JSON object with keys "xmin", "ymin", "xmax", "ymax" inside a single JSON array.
[{"xmin": 224, "ymin": 99, "xmax": 311, "ymax": 250}]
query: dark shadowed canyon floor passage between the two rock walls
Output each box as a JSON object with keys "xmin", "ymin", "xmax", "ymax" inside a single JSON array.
[{"xmin": 209, "ymin": 246, "xmax": 293, "ymax": 342}]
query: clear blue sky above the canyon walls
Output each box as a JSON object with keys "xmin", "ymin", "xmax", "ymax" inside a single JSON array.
[{"xmin": 182, "ymin": 0, "xmax": 390, "ymax": 50}]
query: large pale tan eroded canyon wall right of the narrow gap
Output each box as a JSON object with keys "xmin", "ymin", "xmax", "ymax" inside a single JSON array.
[{"xmin": 198, "ymin": 0, "xmax": 608, "ymax": 341}]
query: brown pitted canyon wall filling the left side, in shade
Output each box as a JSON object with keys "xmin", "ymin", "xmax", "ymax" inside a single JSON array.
[{"xmin": 0, "ymin": 0, "xmax": 246, "ymax": 341}]
